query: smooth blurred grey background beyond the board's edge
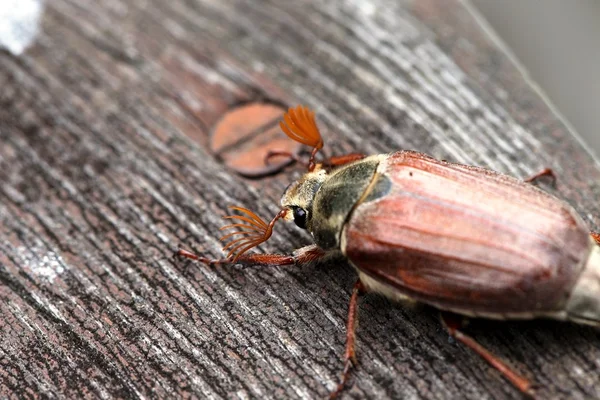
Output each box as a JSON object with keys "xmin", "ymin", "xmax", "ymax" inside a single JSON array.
[{"xmin": 471, "ymin": 0, "xmax": 600, "ymax": 157}]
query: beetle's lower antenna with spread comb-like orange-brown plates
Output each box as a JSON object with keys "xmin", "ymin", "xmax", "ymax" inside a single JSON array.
[{"xmin": 219, "ymin": 206, "xmax": 287, "ymax": 262}]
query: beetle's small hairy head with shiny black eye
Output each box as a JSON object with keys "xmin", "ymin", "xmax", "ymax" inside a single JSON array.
[{"xmin": 281, "ymin": 164, "xmax": 327, "ymax": 232}]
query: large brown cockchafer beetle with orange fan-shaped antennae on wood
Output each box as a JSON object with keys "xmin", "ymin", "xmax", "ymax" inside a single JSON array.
[{"xmin": 177, "ymin": 106, "xmax": 600, "ymax": 398}]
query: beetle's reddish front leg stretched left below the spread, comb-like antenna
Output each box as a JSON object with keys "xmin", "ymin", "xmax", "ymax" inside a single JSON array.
[{"xmin": 175, "ymin": 245, "xmax": 327, "ymax": 266}]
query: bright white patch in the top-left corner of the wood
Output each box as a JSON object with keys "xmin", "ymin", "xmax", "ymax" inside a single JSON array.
[{"xmin": 0, "ymin": 0, "xmax": 44, "ymax": 55}]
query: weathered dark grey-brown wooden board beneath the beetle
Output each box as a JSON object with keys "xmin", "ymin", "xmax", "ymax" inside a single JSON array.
[{"xmin": 0, "ymin": 0, "xmax": 600, "ymax": 399}]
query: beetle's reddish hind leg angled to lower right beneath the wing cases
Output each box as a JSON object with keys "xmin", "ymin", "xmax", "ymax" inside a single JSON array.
[{"xmin": 440, "ymin": 312, "xmax": 534, "ymax": 398}]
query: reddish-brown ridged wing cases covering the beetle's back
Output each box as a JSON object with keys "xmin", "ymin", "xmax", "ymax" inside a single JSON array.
[{"xmin": 341, "ymin": 151, "xmax": 600, "ymax": 319}]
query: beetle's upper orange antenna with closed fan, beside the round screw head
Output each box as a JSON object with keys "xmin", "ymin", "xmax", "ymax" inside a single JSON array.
[{"xmin": 279, "ymin": 105, "xmax": 323, "ymax": 171}]
